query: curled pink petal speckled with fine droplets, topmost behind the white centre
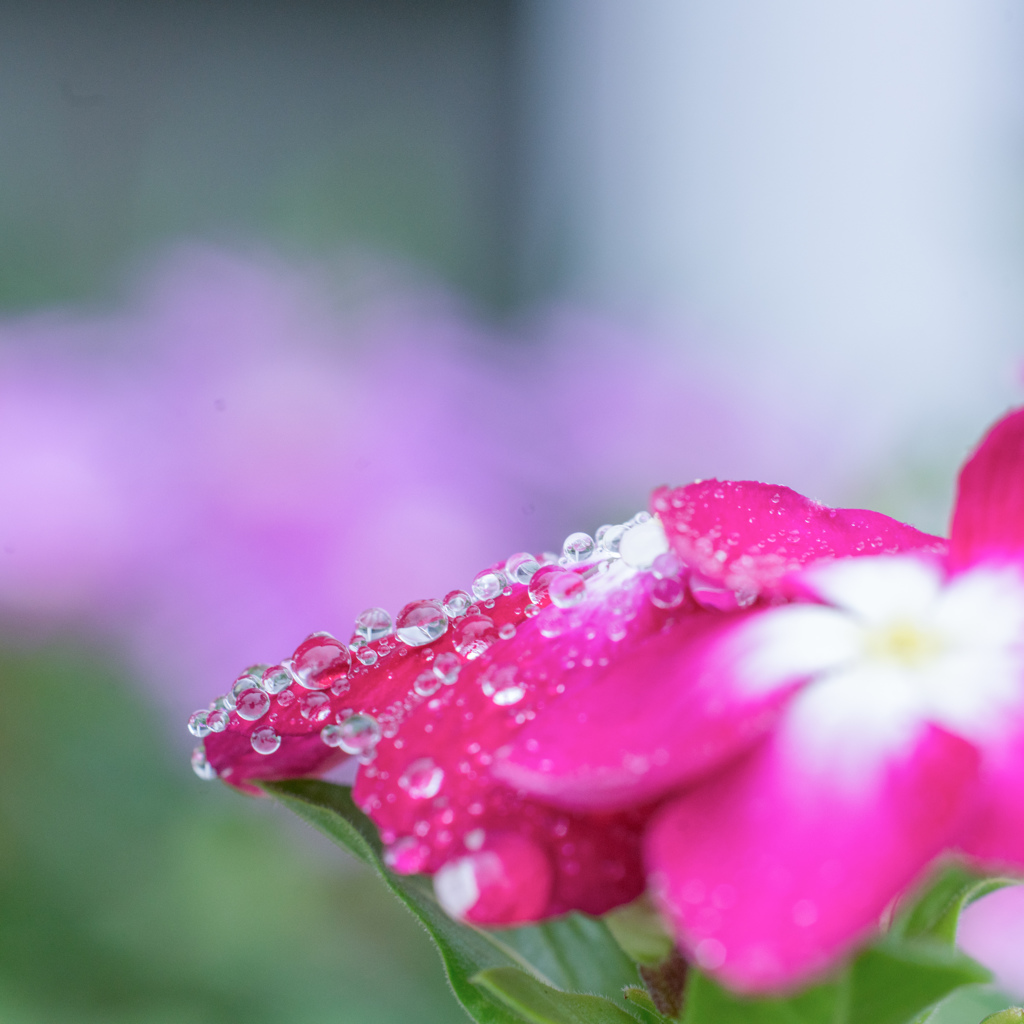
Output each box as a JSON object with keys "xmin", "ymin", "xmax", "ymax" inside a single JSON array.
[{"xmin": 651, "ymin": 480, "xmax": 945, "ymax": 594}]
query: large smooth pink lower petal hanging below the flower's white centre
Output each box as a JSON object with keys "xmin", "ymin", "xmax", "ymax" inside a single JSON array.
[{"xmin": 647, "ymin": 727, "xmax": 977, "ymax": 992}]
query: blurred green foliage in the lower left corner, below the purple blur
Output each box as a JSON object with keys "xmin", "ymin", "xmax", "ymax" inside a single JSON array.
[{"xmin": 0, "ymin": 647, "xmax": 465, "ymax": 1024}]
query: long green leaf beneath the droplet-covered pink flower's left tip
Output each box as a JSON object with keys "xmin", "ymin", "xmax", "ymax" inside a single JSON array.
[{"xmin": 263, "ymin": 779, "xmax": 643, "ymax": 1024}]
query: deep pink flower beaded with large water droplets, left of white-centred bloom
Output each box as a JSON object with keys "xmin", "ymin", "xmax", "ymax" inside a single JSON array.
[{"xmin": 199, "ymin": 481, "xmax": 941, "ymax": 924}]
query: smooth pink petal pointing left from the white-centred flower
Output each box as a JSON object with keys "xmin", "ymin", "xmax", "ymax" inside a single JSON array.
[{"xmin": 495, "ymin": 609, "xmax": 790, "ymax": 810}]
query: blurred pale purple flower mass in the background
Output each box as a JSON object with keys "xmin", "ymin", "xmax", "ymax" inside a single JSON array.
[{"xmin": 0, "ymin": 250, "xmax": 807, "ymax": 713}]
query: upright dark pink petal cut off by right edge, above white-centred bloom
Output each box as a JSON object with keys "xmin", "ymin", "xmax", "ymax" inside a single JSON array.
[{"xmin": 949, "ymin": 410, "xmax": 1024, "ymax": 568}]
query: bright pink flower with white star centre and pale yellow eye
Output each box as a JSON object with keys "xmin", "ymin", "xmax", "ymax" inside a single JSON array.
[{"xmin": 502, "ymin": 412, "xmax": 1024, "ymax": 990}]
